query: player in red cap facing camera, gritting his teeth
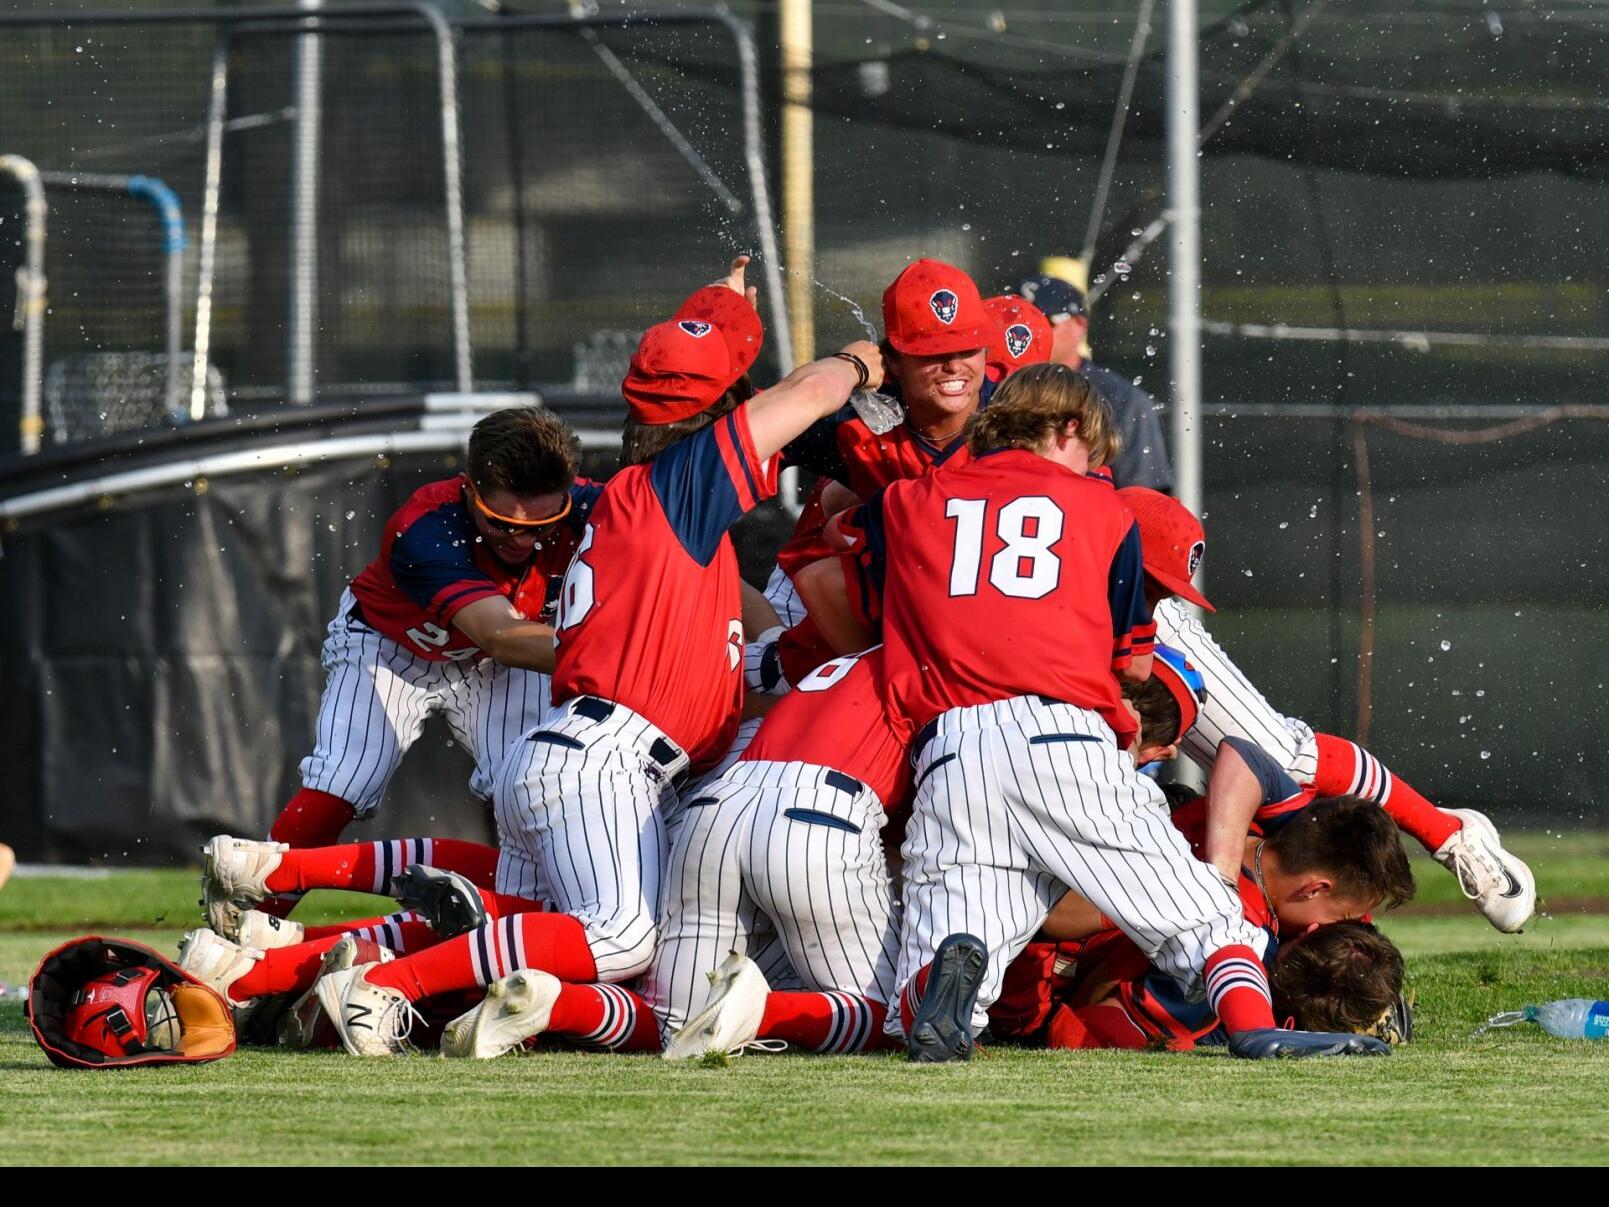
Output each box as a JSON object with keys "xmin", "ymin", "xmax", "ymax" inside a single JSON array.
[{"xmin": 766, "ymin": 259, "xmax": 1002, "ymax": 627}]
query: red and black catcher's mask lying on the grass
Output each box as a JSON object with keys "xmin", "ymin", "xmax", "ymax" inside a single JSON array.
[{"xmin": 27, "ymin": 935, "xmax": 235, "ymax": 1069}]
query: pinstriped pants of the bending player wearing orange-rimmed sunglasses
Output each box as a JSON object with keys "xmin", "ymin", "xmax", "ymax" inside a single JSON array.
[{"xmin": 301, "ymin": 591, "xmax": 552, "ymax": 818}]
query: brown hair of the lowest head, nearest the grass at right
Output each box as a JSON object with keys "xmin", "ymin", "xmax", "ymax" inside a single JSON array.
[{"xmin": 1268, "ymin": 922, "xmax": 1403, "ymax": 1032}]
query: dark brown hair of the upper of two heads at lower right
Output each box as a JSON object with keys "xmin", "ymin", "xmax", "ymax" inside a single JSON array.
[{"xmin": 1268, "ymin": 797, "xmax": 1414, "ymax": 909}]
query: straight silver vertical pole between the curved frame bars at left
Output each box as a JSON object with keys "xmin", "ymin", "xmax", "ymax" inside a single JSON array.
[{"xmin": 285, "ymin": 0, "xmax": 323, "ymax": 407}]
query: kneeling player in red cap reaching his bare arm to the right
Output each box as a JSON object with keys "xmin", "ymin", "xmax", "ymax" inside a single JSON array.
[{"xmin": 317, "ymin": 257, "xmax": 882, "ymax": 1054}]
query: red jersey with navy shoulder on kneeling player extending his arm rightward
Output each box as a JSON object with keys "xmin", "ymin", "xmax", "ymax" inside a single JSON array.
[{"xmin": 553, "ymin": 404, "xmax": 777, "ymax": 768}]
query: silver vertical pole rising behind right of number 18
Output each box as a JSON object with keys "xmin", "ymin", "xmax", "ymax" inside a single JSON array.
[{"xmin": 1167, "ymin": 0, "xmax": 1202, "ymax": 527}]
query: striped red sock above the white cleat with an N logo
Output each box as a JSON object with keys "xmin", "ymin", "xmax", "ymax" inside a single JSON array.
[{"xmin": 368, "ymin": 914, "xmax": 599, "ymax": 1001}]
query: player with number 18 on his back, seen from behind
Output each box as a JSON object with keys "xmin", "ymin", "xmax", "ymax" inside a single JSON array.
[{"xmin": 829, "ymin": 365, "xmax": 1384, "ymax": 1061}]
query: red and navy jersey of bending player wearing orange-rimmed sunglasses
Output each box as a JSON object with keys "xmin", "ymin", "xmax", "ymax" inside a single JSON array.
[{"xmin": 352, "ymin": 478, "xmax": 603, "ymax": 661}]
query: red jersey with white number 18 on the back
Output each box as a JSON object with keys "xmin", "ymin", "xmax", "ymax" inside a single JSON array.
[{"xmin": 840, "ymin": 449, "xmax": 1155, "ymax": 747}]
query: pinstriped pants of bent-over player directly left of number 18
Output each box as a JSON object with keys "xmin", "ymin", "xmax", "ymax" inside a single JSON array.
[{"xmin": 639, "ymin": 761, "xmax": 899, "ymax": 1032}]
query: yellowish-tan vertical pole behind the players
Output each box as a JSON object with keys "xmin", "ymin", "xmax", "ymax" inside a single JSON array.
[{"xmin": 779, "ymin": 0, "xmax": 816, "ymax": 368}]
